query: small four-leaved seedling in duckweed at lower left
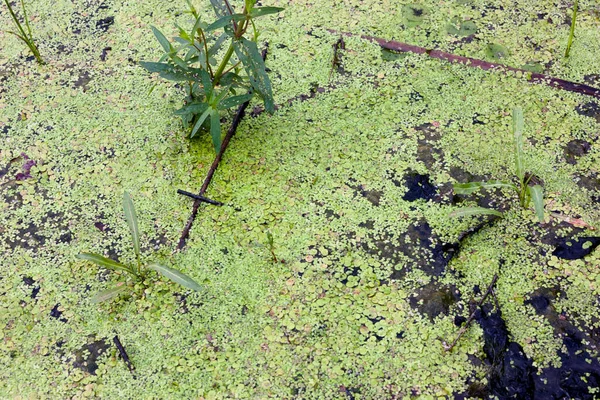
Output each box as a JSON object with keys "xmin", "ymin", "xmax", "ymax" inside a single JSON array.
[{"xmin": 77, "ymin": 192, "xmax": 202, "ymax": 303}]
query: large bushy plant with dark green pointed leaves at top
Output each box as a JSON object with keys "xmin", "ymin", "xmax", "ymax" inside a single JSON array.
[{"xmin": 140, "ymin": 0, "xmax": 283, "ymax": 153}]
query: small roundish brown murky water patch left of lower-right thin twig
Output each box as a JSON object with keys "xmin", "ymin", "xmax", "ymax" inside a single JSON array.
[{"xmin": 409, "ymin": 281, "xmax": 460, "ymax": 322}]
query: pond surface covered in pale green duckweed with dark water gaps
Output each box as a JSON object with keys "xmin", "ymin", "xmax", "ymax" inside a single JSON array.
[{"xmin": 0, "ymin": 0, "xmax": 600, "ymax": 399}]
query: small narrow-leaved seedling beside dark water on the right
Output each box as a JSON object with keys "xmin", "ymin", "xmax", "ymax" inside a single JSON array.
[{"xmin": 450, "ymin": 108, "xmax": 544, "ymax": 222}]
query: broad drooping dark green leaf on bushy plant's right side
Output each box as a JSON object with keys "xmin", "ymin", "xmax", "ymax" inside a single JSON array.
[{"xmin": 233, "ymin": 38, "xmax": 275, "ymax": 114}]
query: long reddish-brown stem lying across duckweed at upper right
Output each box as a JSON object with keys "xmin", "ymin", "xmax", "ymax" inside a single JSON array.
[{"xmin": 328, "ymin": 29, "xmax": 600, "ymax": 99}]
